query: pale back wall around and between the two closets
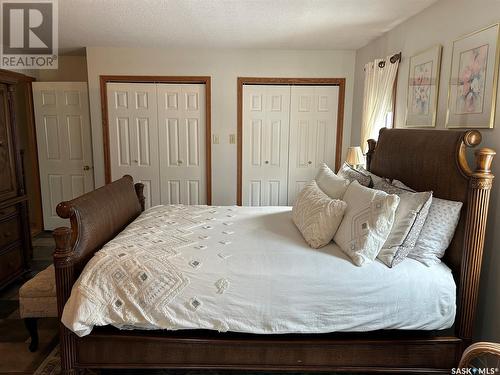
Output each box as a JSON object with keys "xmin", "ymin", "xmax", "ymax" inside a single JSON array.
[{"xmin": 87, "ymin": 47, "xmax": 355, "ymax": 205}]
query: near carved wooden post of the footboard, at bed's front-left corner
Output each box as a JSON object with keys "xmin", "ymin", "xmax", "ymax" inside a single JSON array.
[{"xmin": 53, "ymin": 228, "xmax": 76, "ymax": 374}]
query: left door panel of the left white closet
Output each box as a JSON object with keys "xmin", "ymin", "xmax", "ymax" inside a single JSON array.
[{"xmin": 107, "ymin": 83, "xmax": 160, "ymax": 208}]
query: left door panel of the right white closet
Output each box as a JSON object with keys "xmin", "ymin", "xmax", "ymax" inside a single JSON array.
[{"xmin": 242, "ymin": 85, "xmax": 290, "ymax": 206}]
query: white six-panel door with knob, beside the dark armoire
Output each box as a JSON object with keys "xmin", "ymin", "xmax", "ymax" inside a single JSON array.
[{"xmin": 33, "ymin": 82, "xmax": 94, "ymax": 230}]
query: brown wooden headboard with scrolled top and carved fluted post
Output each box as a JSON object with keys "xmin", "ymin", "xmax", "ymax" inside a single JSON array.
[{"xmin": 367, "ymin": 129, "xmax": 495, "ymax": 339}]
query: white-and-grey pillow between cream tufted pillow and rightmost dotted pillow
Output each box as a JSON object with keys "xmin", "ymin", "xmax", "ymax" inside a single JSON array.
[{"xmin": 373, "ymin": 179, "xmax": 432, "ymax": 267}]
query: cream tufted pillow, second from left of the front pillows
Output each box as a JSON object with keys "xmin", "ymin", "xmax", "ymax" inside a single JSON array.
[{"xmin": 334, "ymin": 181, "xmax": 399, "ymax": 266}]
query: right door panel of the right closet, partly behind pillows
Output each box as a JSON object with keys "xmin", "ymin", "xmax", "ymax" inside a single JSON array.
[{"xmin": 288, "ymin": 86, "xmax": 339, "ymax": 206}]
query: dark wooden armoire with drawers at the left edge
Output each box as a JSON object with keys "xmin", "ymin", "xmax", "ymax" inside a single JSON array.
[{"xmin": 0, "ymin": 71, "xmax": 31, "ymax": 289}]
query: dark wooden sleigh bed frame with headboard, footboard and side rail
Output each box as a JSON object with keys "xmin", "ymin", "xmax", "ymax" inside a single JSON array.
[{"xmin": 54, "ymin": 129, "xmax": 495, "ymax": 374}]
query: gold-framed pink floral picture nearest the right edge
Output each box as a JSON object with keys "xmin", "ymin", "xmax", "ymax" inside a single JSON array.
[{"xmin": 446, "ymin": 23, "xmax": 500, "ymax": 128}]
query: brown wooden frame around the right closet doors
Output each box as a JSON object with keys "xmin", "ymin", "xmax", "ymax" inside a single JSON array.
[{"xmin": 236, "ymin": 77, "xmax": 345, "ymax": 206}]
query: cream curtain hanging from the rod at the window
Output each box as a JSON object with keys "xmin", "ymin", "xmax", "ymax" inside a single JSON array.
[{"xmin": 361, "ymin": 56, "xmax": 399, "ymax": 151}]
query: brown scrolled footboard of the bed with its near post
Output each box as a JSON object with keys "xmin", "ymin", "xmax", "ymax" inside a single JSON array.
[{"xmin": 53, "ymin": 175, "xmax": 144, "ymax": 374}]
